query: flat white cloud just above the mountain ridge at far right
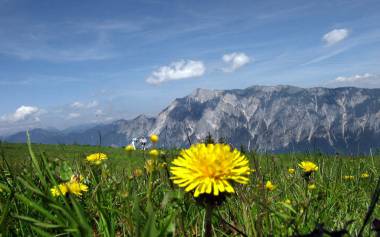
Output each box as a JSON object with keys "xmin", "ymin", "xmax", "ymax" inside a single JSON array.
[{"xmin": 328, "ymin": 73, "xmax": 380, "ymax": 88}]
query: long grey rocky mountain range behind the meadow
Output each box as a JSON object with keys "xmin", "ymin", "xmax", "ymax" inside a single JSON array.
[{"xmin": 6, "ymin": 86, "xmax": 380, "ymax": 153}]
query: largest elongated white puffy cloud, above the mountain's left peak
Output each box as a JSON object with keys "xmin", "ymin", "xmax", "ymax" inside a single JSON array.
[{"xmin": 146, "ymin": 60, "xmax": 206, "ymax": 84}]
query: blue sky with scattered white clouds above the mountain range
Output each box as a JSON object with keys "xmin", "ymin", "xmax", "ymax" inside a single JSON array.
[{"xmin": 0, "ymin": 0, "xmax": 380, "ymax": 135}]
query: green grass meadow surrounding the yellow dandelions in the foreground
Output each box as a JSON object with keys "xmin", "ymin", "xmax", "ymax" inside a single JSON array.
[{"xmin": 0, "ymin": 144, "xmax": 380, "ymax": 236}]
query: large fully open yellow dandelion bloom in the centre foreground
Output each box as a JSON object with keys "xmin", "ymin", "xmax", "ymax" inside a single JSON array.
[{"xmin": 170, "ymin": 144, "xmax": 251, "ymax": 197}]
